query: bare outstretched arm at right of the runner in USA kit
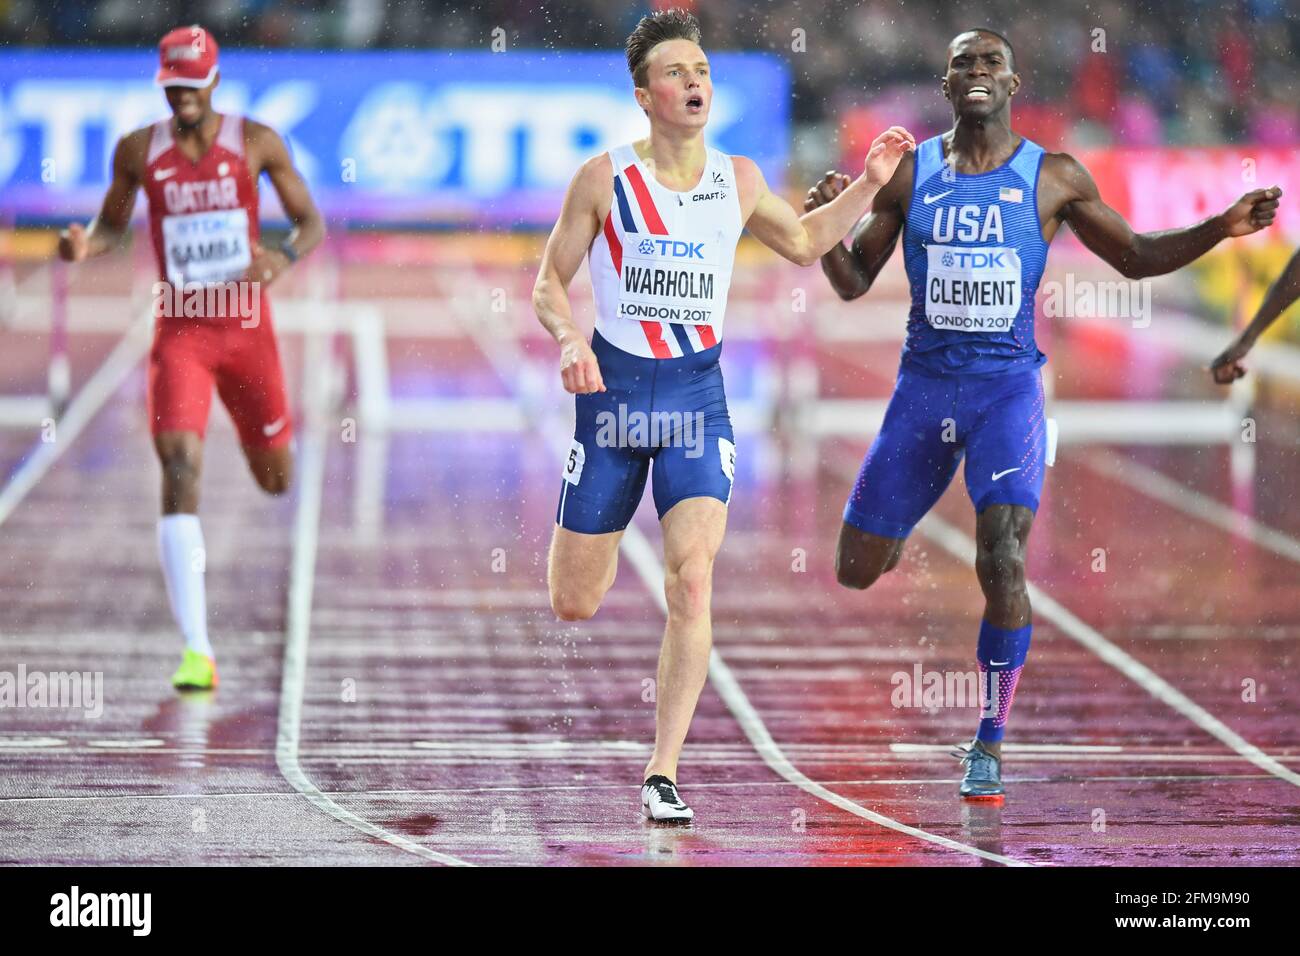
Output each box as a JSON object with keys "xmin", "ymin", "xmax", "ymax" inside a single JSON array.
[{"xmin": 1040, "ymin": 153, "xmax": 1282, "ymax": 278}]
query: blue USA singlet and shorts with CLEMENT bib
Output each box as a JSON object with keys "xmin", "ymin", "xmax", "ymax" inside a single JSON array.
[{"xmin": 844, "ymin": 137, "xmax": 1049, "ymax": 538}]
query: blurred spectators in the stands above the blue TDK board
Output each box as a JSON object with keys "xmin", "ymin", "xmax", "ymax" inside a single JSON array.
[{"xmin": 10, "ymin": 0, "xmax": 1300, "ymax": 153}]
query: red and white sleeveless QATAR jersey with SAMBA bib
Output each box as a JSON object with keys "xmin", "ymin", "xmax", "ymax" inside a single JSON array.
[{"xmin": 144, "ymin": 116, "xmax": 259, "ymax": 295}]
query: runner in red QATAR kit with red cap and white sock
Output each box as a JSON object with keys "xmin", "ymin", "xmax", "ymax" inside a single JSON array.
[{"xmin": 59, "ymin": 26, "xmax": 325, "ymax": 689}]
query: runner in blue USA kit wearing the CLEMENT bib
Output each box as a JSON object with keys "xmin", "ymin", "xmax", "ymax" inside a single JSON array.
[{"xmin": 805, "ymin": 30, "xmax": 1281, "ymax": 800}]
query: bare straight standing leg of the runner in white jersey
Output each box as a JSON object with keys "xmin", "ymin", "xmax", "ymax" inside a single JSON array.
[{"xmin": 645, "ymin": 497, "xmax": 727, "ymax": 780}]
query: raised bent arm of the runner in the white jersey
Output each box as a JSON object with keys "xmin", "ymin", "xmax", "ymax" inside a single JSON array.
[{"xmin": 735, "ymin": 126, "xmax": 917, "ymax": 265}]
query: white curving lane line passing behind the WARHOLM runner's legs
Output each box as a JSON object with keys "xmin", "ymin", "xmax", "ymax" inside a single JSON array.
[{"xmin": 464, "ymin": 321, "xmax": 1037, "ymax": 866}]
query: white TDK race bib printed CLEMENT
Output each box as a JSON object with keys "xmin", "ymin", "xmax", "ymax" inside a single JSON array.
[{"xmin": 926, "ymin": 245, "xmax": 1021, "ymax": 332}]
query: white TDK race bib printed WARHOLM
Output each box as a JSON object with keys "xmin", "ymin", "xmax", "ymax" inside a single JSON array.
[{"xmin": 619, "ymin": 233, "xmax": 727, "ymax": 325}]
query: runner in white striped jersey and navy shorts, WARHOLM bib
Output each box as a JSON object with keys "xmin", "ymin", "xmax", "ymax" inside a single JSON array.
[{"xmin": 533, "ymin": 10, "xmax": 915, "ymax": 822}]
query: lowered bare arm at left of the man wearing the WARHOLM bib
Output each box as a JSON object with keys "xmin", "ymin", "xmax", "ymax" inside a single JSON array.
[{"xmin": 533, "ymin": 155, "xmax": 614, "ymax": 394}]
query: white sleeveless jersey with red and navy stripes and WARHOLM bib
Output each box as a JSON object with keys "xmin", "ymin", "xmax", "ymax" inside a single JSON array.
[{"xmin": 588, "ymin": 144, "xmax": 744, "ymax": 359}]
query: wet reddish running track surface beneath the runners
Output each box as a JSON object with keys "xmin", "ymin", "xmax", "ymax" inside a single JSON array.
[{"xmin": 0, "ymin": 290, "xmax": 1300, "ymax": 865}]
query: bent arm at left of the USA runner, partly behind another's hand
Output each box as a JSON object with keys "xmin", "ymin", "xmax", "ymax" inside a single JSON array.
[{"xmin": 803, "ymin": 156, "xmax": 914, "ymax": 302}]
